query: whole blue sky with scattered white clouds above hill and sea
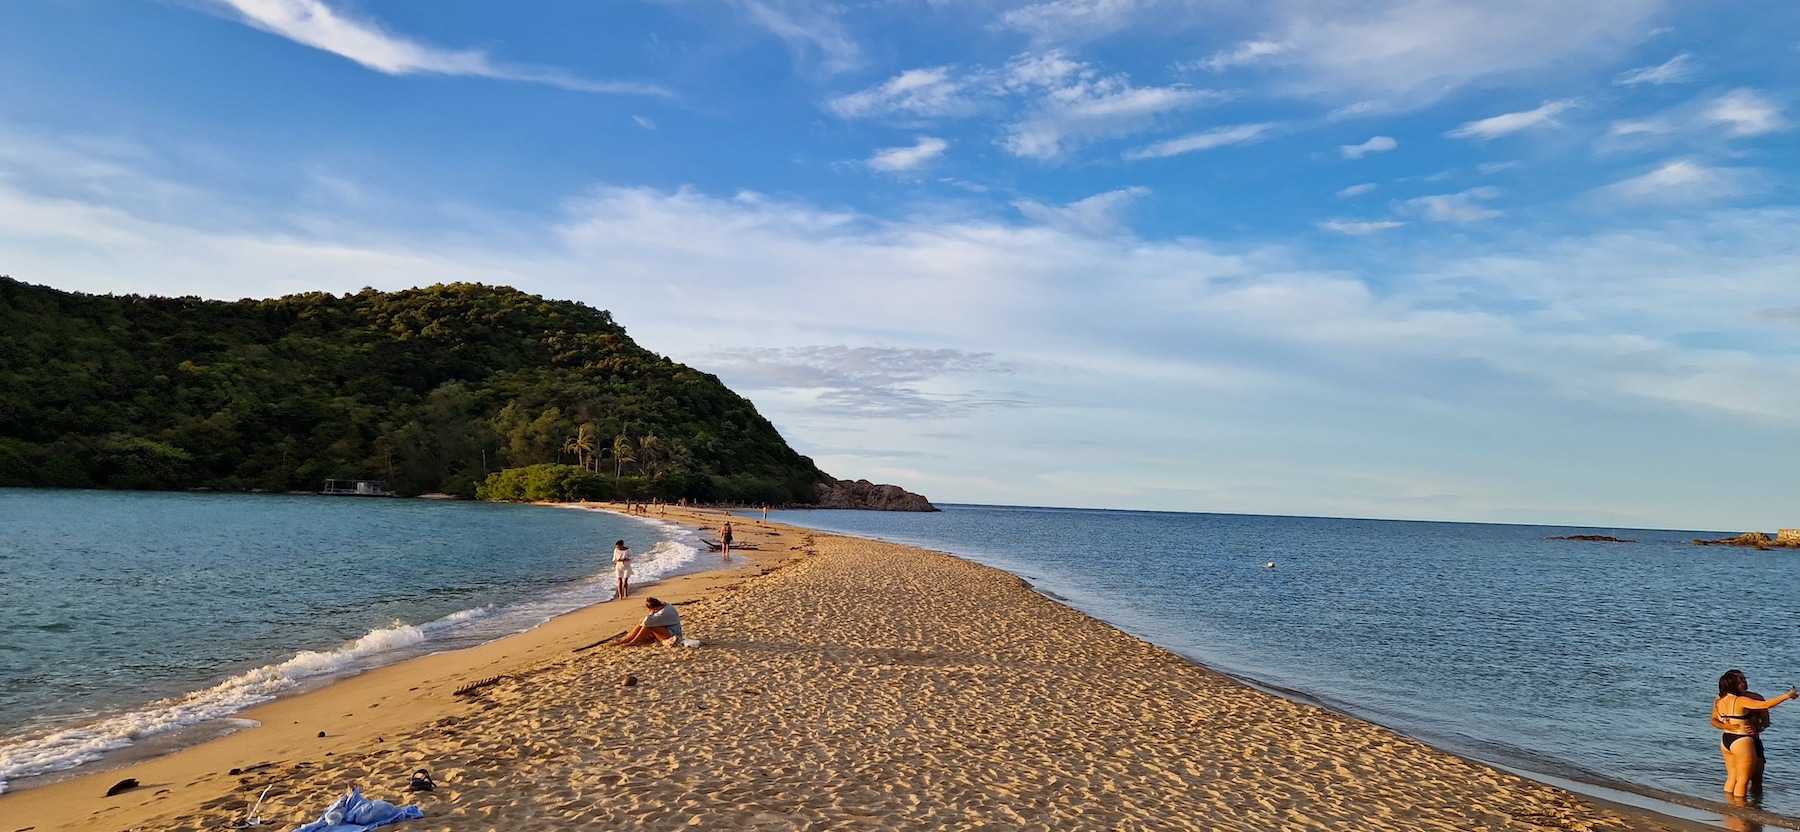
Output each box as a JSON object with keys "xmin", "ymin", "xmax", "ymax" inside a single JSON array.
[{"xmin": 0, "ymin": 0, "xmax": 1800, "ymax": 529}]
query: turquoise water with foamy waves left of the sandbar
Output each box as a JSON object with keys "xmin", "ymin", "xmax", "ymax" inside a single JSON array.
[{"xmin": 0, "ymin": 488, "xmax": 716, "ymax": 791}]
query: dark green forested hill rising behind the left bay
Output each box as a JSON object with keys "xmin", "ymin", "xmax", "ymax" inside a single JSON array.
[{"xmin": 0, "ymin": 277, "xmax": 826, "ymax": 502}]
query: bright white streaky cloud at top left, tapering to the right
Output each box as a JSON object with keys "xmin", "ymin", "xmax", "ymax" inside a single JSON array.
[{"xmin": 207, "ymin": 0, "xmax": 666, "ymax": 95}]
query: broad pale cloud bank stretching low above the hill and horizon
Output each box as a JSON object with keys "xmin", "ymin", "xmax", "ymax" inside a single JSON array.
[{"xmin": 0, "ymin": 132, "xmax": 1800, "ymax": 528}]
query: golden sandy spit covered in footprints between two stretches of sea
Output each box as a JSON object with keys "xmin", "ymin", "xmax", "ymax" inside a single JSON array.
[{"xmin": 0, "ymin": 511, "xmax": 1694, "ymax": 832}]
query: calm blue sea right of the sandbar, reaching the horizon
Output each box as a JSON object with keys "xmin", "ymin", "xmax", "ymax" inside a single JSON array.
[{"xmin": 770, "ymin": 506, "xmax": 1800, "ymax": 818}]
